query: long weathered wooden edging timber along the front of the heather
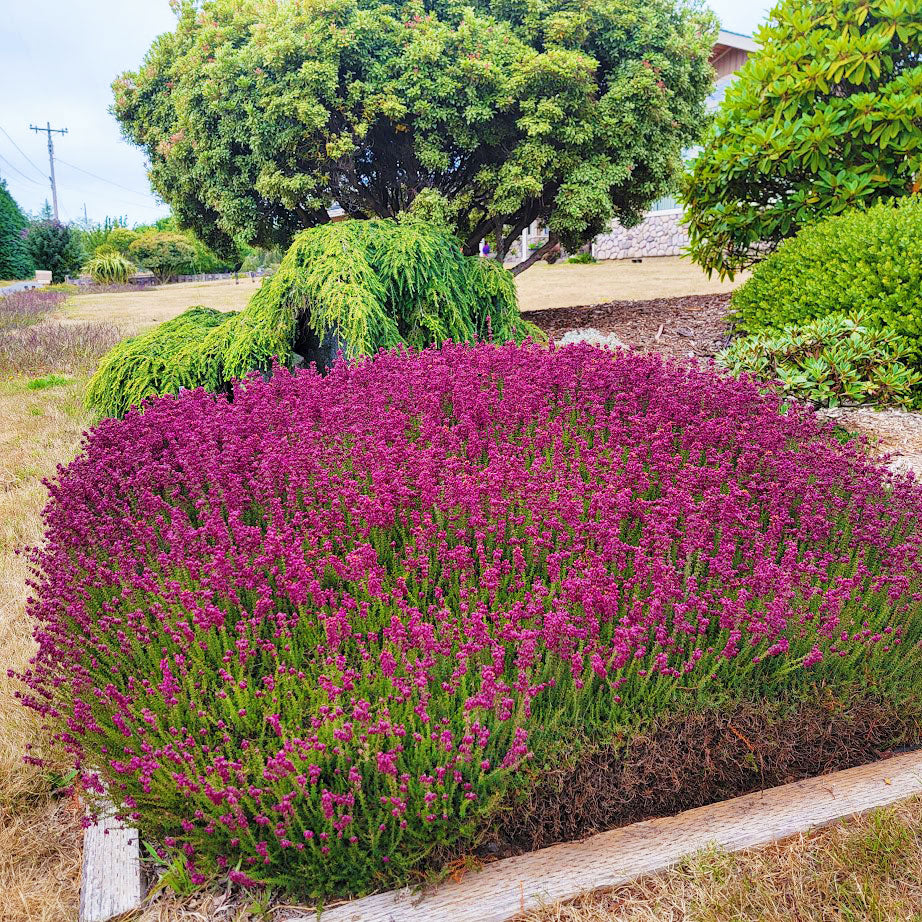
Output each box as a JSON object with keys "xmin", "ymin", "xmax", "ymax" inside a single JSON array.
[{"xmin": 286, "ymin": 752, "xmax": 922, "ymax": 922}]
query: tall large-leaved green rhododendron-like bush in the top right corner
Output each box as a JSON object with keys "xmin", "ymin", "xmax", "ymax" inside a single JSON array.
[{"xmin": 683, "ymin": 0, "xmax": 922, "ymax": 276}]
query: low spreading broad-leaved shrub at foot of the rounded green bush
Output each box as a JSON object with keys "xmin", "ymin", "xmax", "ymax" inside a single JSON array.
[{"xmin": 717, "ymin": 313, "xmax": 922, "ymax": 406}]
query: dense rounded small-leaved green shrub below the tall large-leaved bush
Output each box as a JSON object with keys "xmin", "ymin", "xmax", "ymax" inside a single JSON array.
[{"xmin": 730, "ymin": 196, "xmax": 922, "ymax": 392}]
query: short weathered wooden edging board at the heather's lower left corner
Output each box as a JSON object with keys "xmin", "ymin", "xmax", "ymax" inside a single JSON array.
[{"xmin": 80, "ymin": 809, "xmax": 144, "ymax": 922}]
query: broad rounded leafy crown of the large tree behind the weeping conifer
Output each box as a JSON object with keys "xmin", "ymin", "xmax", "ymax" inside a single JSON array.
[{"xmin": 113, "ymin": 0, "xmax": 716, "ymax": 270}]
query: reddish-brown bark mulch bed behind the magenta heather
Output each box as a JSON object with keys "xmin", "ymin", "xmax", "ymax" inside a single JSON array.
[{"xmin": 525, "ymin": 294, "xmax": 730, "ymax": 359}]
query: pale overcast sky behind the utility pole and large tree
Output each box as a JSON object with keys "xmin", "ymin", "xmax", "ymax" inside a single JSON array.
[{"xmin": 0, "ymin": 0, "xmax": 771, "ymax": 224}]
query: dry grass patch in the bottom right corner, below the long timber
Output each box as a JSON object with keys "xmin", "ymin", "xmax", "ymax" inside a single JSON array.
[{"xmin": 519, "ymin": 798, "xmax": 922, "ymax": 922}]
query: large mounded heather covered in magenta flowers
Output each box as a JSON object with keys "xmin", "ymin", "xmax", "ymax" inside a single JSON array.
[{"xmin": 12, "ymin": 345, "xmax": 922, "ymax": 897}]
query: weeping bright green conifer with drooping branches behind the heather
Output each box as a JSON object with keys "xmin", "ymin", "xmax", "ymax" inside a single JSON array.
[{"xmin": 87, "ymin": 220, "xmax": 543, "ymax": 417}]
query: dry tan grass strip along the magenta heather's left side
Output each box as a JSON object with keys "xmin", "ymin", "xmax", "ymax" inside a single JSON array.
[{"xmin": 0, "ymin": 379, "xmax": 88, "ymax": 922}]
